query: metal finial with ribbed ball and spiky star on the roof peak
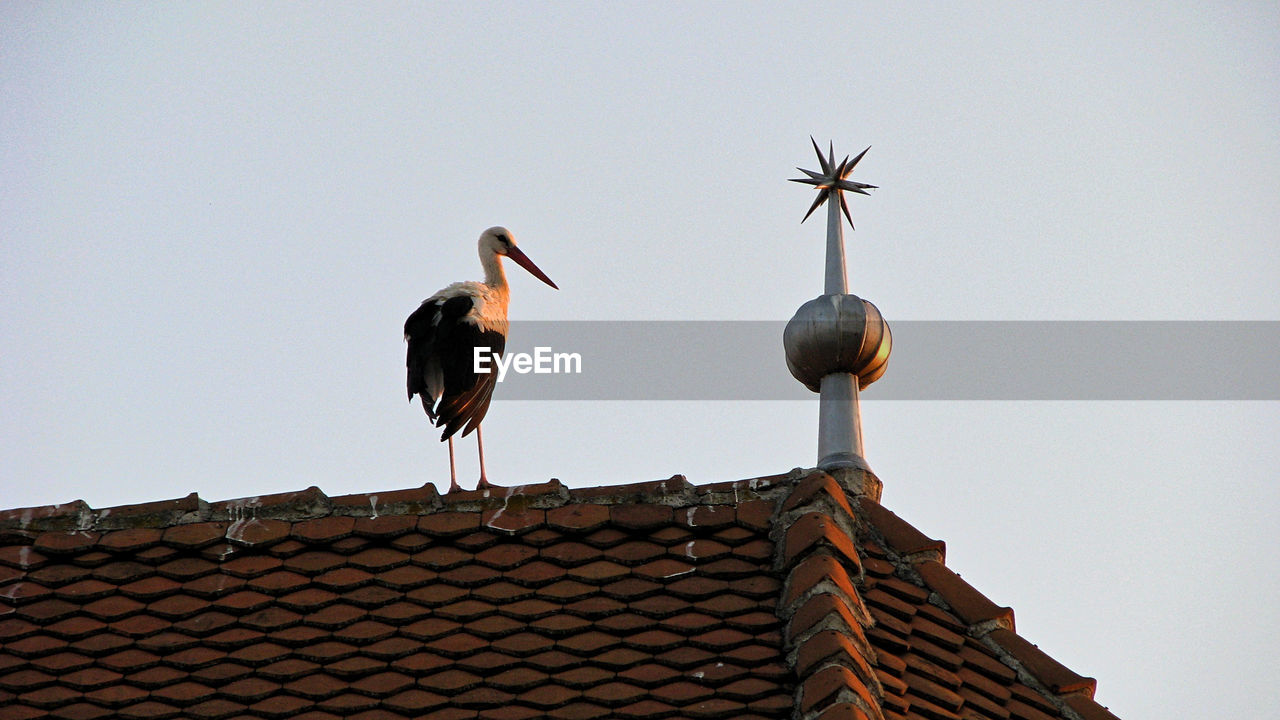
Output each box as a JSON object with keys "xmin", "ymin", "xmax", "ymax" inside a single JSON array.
[{"xmin": 783, "ymin": 138, "xmax": 891, "ymax": 471}]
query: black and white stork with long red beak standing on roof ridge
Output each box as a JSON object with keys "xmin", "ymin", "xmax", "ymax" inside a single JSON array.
[{"xmin": 404, "ymin": 227, "xmax": 559, "ymax": 492}]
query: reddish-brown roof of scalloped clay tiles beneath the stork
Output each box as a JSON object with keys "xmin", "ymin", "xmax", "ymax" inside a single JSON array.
[{"xmin": 0, "ymin": 471, "xmax": 1112, "ymax": 720}]
